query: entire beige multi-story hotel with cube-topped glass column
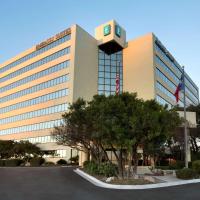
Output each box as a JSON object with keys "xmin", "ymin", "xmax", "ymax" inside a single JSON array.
[{"xmin": 0, "ymin": 20, "xmax": 199, "ymax": 162}]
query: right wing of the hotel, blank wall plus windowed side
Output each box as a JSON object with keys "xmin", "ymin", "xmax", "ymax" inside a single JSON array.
[{"xmin": 123, "ymin": 33, "xmax": 199, "ymax": 108}]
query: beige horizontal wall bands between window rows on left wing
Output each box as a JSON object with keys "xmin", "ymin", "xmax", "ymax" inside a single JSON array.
[{"xmin": 0, "ymin": 29, "xmax": 74, "ymax": 140}]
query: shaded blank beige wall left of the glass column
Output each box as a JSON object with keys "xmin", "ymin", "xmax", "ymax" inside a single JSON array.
[{"xmin": 71, "ymin": 25, "xmax": 98, "ymax": 101}]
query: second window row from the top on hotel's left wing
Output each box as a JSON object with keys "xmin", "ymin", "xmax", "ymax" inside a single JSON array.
[{"xmin": 0, "ymin": 47, "xmax": 70, "ymax": 82}]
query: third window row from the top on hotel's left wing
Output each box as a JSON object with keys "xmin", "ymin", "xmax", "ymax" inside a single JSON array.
[{"xmin": 0, "ymin": 60, "xmax": 70, "ymax": 93}]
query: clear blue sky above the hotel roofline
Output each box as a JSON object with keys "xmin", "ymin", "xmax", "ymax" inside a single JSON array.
[{"xmin": 0, "ymin": 0, "xmax": 200, "ymax": 87}]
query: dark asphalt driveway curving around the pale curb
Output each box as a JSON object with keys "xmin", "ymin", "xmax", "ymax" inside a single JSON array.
[{"xmin": 0, "ymin": 167, "xmax": 200, "ymax": 200}]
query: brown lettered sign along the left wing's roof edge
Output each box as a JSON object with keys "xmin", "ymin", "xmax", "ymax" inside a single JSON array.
[{"xmin": 36, "ymin": 28, "xmax": 71, "ymax": 50}]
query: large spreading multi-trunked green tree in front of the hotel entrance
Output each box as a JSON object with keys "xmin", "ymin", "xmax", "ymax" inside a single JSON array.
[{"xmin": 52, "ymin": 92, "xmax": 180, "ymax": 178}]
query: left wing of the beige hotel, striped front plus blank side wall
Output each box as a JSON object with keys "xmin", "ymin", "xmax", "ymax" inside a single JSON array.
[{"xmin": 0, "ymin": 25, "xmax": 98, "ymax": 161}]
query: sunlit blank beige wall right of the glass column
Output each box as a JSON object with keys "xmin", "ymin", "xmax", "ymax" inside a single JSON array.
[{"xmin": 123, "ymin": 33, "xmax": 155, "ymax": 100}]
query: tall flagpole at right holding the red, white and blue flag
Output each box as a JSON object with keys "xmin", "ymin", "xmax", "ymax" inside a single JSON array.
[{"xmin": 182, "ymin": 66, "xmax": 188, "ymax": 168}]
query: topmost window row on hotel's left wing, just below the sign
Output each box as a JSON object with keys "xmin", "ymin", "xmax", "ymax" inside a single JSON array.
[{"xmin": 0, "ymin": 34, "xmax": 71, "ymax": 73}]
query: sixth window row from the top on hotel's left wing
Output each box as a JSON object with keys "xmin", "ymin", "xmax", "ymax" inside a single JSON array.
[{"xmin": 0, "ymin": 103, "xmax": 68, "ymax": 124}]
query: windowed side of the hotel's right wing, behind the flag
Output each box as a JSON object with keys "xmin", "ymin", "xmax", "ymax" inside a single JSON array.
[{"xmin": 153, "ymin": 35, "xmax": 199, "ymax": 107}]
